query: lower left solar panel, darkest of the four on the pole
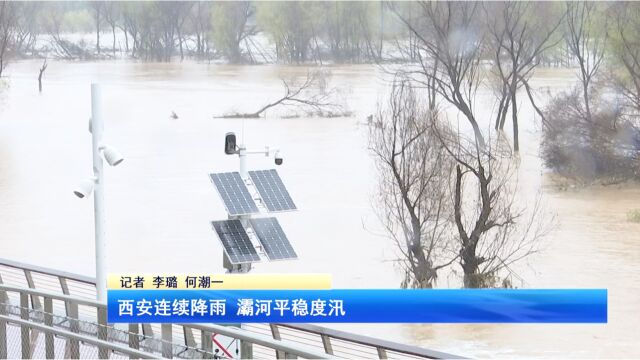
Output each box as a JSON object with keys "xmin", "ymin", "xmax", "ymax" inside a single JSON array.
[{"xmin": 211, "ymin": 220, "xmax": 260, "ymax": 264}]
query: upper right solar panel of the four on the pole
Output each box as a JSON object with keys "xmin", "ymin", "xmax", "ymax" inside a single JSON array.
[{"xmin": 249, "ymin": 169, "xmax": 296, "ymax": 211}]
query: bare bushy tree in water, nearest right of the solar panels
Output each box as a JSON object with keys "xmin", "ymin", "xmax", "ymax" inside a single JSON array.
[{"xmin": 369, "ymin": 78, "xmax": 458, "ymax": 288}]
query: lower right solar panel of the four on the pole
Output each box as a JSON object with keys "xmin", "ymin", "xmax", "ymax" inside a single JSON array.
[{"xmin": 250, "ymin": 218, "xmax": 298, "ymax": 260}]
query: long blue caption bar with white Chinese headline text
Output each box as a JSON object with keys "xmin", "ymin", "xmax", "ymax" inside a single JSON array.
[{"xmin": 108, "ymin": 289, "xmax": 607, "ymax": 323}]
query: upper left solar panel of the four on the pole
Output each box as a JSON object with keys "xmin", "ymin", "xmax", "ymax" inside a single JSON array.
[{"xmin": 209, "ymin": 172, "xmax": 258, "ymax": 215}]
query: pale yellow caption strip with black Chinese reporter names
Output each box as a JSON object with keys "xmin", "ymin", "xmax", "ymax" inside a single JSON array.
[{"xmin": 107, "ymin": 274, "xmax": 331, "ymax": 290}]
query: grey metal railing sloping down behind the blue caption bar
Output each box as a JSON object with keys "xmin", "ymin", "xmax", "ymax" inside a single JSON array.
[{"xmin": 0, "ymin": 258, "xmax": 459, "ymax": 359}]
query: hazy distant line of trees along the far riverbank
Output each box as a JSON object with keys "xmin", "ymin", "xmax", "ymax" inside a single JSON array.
[{"xmin": 0, "ymin": 1, "xmax": 592, "ymax": 68}]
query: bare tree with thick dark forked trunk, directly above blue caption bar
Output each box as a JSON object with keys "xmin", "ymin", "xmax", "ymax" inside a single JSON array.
[{"xmin": 438, "ymin": 125, "xmax": 551, "ymax": 288}]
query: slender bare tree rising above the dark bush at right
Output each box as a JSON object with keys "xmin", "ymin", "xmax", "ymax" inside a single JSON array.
[{"xmin": 565, "ymin": 1, "xmax": 607, "ymax": 122}]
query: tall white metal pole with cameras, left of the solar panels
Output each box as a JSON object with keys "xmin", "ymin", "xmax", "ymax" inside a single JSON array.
[{"xmin": 91, "ymin": 84, "xmax": 107, "ymax": 302}]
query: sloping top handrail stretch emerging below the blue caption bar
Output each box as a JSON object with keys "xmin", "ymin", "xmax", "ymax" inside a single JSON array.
[{"xmin": 277, "ymin": 324, "xmax": 465, "ymax": 359}]
